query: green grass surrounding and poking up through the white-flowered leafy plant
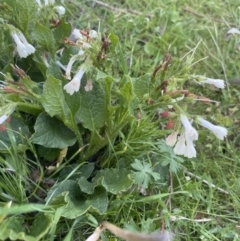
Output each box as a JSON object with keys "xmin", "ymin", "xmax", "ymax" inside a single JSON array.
[{"xmin": 0, "ymin": 0, "xmax": 240, "ymax": 241}]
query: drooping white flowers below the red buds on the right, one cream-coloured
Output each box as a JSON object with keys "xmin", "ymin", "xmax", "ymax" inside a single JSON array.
[{"xmin": 166, "ymin": 115, "xmax": 227, "ymax": 158}]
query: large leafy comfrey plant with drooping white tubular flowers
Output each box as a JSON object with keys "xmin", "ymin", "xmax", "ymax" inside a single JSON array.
[{"xmin": 0, "ymin": 0, "xmax": 227, "ymax": 240}]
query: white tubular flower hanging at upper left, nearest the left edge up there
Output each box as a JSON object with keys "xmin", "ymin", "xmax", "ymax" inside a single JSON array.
[{"xmin": 11, "ymin": 32, "xmax": 36, "ymax": 58}]
